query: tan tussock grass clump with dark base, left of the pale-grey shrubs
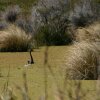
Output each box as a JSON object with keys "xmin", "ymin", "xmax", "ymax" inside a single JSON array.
[{"xmin": 0, "ymin": 25, "xmax": 32, "ymax": 52}]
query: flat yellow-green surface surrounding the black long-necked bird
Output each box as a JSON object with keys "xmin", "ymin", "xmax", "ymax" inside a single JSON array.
[{"xmin": 0, "ymin": 46, "xmax": 96, "ymax": 100}]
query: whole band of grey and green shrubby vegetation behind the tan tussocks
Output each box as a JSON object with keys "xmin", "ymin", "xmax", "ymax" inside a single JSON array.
[{"xmin": 0, "ymin": 0, "xmax": 100, "ymax": 46}]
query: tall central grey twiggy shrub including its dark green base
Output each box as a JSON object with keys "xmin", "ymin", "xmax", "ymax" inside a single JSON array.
[{"xmin": 32, "ymin": 0, "xmax": 72, "ymax": 45}]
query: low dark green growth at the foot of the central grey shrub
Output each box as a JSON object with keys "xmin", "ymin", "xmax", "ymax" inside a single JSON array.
[{"xmin": 34, "ymin": 25, "xmax": 72, "ymax": 45}]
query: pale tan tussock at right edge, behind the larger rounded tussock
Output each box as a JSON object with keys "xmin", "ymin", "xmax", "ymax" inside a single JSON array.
[{"xmin": 76, "ymin": 22, "xmax": 100, "ymax": 42}]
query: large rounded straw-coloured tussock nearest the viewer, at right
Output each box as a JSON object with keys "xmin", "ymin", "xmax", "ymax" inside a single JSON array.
[{"xmin": 66, "ymin": 41, "xmax": 99, "ymax": 80}]
